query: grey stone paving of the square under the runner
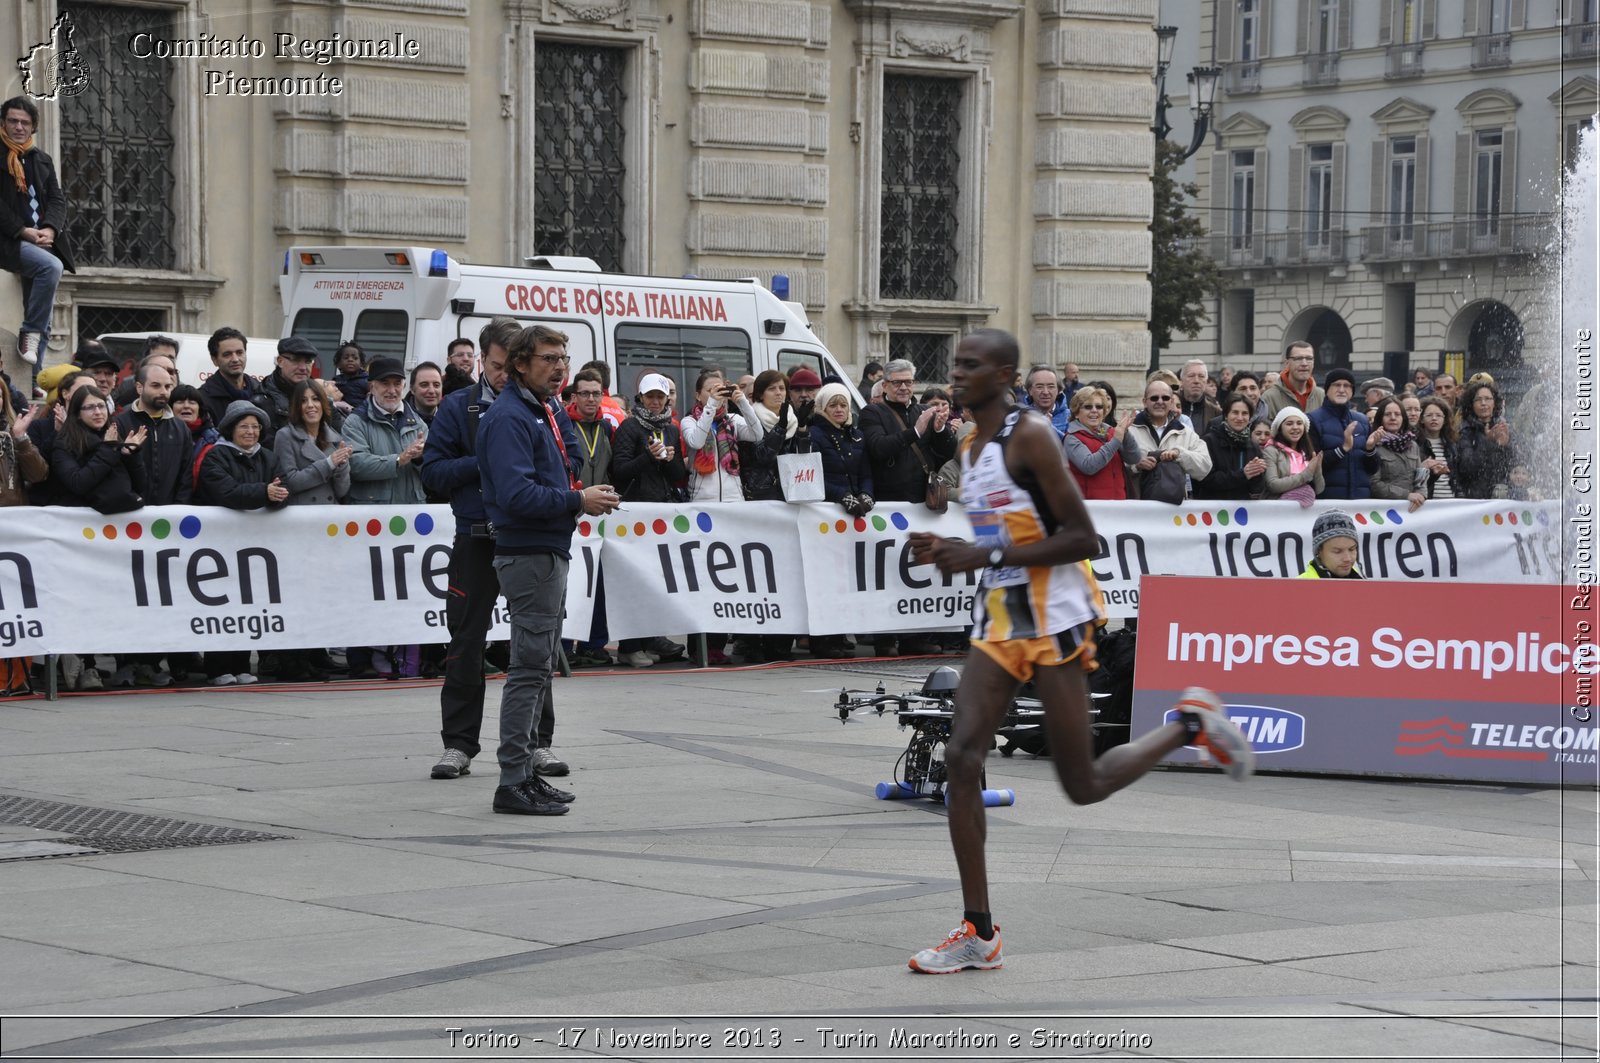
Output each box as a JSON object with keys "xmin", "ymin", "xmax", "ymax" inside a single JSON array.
[{"xmin": 0, "ymin": 669, "xmax": 1597, "ymax": 1058}]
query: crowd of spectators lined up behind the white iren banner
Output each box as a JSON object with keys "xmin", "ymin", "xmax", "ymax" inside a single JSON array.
[{"xmin": 0, "ymin": 328, "xmax": 1530, "ymax": 690}]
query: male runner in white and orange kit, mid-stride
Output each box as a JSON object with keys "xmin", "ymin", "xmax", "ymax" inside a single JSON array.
[{"xmin": 910, "ymin": 328, "xmax": 1254, "ymax": 975}]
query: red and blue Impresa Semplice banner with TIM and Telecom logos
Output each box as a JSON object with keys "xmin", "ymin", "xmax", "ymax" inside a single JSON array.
[{"xmin": 1133, "ymin": 576, "xmax": 1600, "ymax": 784}]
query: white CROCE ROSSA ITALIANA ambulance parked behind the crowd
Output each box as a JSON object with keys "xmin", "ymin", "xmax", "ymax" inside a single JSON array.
[{"xmin": 280, "ymin": 247, "xmax": 854, "ymax": 413}]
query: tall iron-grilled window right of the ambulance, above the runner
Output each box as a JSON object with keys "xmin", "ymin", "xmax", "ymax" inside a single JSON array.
[{"xmin": 878, "ymin": 74, "xmax": 963, "ymax": 300}]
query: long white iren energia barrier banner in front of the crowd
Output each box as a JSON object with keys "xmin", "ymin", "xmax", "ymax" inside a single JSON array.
[{"xmin": 0, "ymin": 499, "xmax": 1563, "ymax": 656}]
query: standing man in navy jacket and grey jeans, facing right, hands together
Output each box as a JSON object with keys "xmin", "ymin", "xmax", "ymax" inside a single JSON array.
[{"xmin": 469, "ymin": 325, "xmax": 621, "ymax": 815}]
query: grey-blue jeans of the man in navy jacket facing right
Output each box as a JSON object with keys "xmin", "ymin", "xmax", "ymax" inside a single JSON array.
[{"xmin": 494, "ymin": 554, "xmax": 568, "ymax": 786}]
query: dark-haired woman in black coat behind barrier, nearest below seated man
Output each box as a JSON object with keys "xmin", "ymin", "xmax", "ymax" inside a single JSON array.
[{"xmin": 50, "ymin": 384, "xmax": 146, "ymax": 512}]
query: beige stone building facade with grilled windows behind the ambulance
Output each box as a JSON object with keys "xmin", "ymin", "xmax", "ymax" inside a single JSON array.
[{"xmin": 0, "ymin": 0, "xmax": 1157, "ymax": 390}]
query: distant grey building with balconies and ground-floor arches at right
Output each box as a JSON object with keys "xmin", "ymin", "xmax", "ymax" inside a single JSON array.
[{"xmin": 1162, "ymin": 0, "xmax": 1600, "ymax": 389}]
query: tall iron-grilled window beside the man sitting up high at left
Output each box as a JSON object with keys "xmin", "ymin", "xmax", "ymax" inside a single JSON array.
[{"xmin": 59, "ymin": 2, "xmax": 178, "ymax": 269}]
